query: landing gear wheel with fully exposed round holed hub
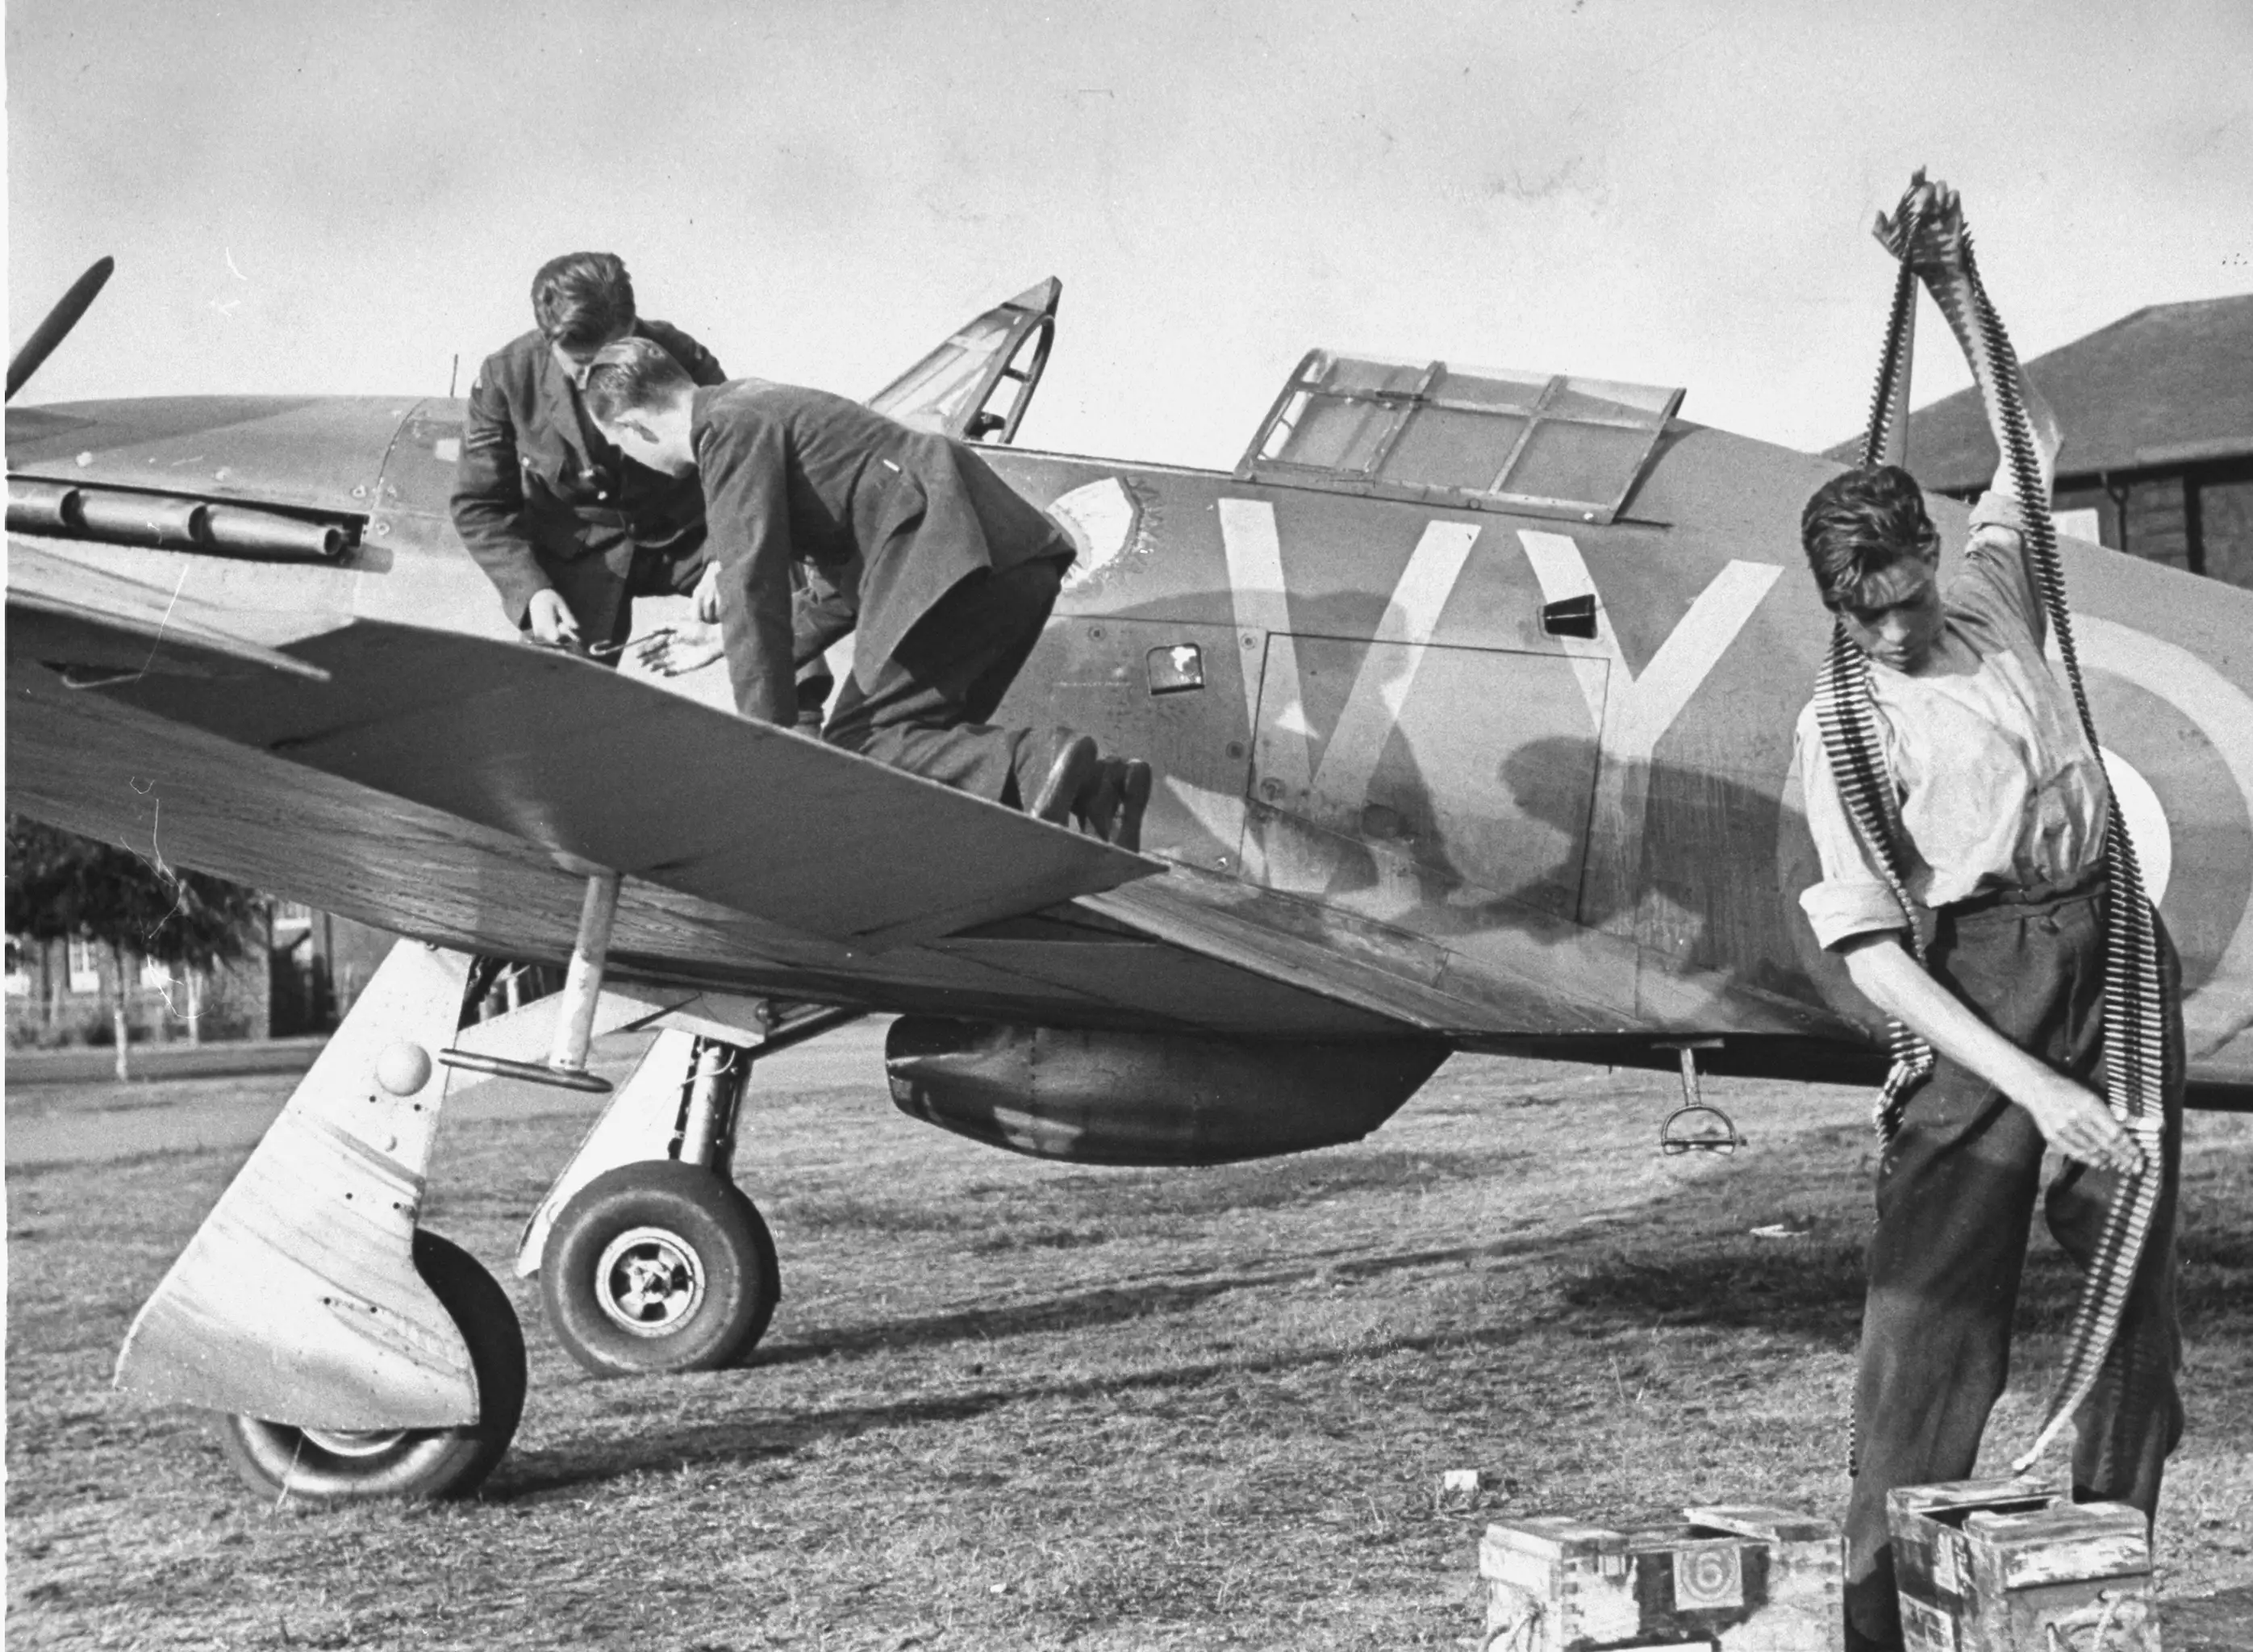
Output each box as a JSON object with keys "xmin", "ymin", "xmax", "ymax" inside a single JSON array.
[{"xmin": 540, "ymin": 1158, "xmax": 782, "ymax": 1377}]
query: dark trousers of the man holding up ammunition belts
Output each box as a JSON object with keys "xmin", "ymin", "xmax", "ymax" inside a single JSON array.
[{"xmin": 1845, "ymin": 886, "xmax": 2183, "ymax": 1647}]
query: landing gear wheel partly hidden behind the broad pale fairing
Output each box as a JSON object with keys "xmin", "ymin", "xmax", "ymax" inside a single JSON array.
[{"xmin": 219, "ymin": 1233, "xmax": 525, "ymax": 1508}]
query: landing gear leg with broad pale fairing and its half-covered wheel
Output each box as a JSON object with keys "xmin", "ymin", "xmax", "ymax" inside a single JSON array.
[{"xmin": 117, "ymin": 942, "xmax": 525, "ymax": 1504}]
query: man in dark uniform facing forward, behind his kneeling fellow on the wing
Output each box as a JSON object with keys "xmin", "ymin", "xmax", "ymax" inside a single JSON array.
[{"xmin": 453, "ymin": 252, "xmax": 725, "ymax": 647}]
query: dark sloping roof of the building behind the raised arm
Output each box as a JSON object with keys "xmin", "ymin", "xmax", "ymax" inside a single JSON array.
[{"xmin": 1830, "ymin": 293, "xmax": 2253, "ymax": 494}]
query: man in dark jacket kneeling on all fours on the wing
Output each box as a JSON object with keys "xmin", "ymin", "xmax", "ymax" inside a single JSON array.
[{"xmin": 586, "ymin": 338, "xmax": 1151, "ymax": 848}]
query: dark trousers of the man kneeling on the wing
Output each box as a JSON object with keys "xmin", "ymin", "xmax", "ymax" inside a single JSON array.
[{"xmin": 822, "ymin": 561, "xmax": 1070, "ymax": 809}]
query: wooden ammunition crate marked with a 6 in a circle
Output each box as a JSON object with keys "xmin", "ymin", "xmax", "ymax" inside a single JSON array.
[{"xmin": 1478, "ymin": 1505, "xmax": 1845, "ymax": 1652}]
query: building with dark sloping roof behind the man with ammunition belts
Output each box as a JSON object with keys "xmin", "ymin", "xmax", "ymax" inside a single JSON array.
[{"xmin": 1832, "ymin": 293, "xmax": 2253, "ymax": 588}]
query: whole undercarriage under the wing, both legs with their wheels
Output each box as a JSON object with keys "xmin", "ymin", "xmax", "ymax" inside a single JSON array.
[{"xmin": 117, "ymin": 883, "xmax": 861, "ymax": 1505}]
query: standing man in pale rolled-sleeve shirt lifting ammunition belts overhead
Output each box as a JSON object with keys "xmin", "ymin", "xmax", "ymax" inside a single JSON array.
[{"xmin": 1798, "ymin": 185, "xmax": 2183, "ymax": 1650}]
